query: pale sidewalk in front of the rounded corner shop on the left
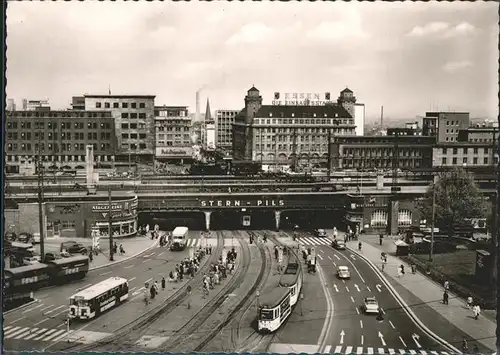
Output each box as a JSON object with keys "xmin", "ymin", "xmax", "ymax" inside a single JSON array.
[{"xmin": 45, "ymin": 233, "xmax": 159, "ymax": 270}]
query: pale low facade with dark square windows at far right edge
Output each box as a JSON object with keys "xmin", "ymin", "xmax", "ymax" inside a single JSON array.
[{"xmin": 432, "ymin": 142, "xmax": 498, "ymax": 167}]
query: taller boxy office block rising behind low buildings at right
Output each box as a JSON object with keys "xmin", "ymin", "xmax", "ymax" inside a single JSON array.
[{"xmin": 422, "ymin": 112, "xmax": 469, "ymax": 143}]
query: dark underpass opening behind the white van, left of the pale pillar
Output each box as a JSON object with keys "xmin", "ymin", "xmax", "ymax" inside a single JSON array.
[{"xmin": 139, "ymin": 212, "xmax": 205, "ymax": 231}]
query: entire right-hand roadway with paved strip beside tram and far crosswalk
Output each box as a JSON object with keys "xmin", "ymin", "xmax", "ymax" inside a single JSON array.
[{"xmin": 274, "ymin": 233, "xmax": 454, "ymax": 354}]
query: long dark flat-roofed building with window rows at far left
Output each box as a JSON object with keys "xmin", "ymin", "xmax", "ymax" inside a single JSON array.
[{"xmin": 5, "ymin": 111, "xmax": 116, "ymax": 173}]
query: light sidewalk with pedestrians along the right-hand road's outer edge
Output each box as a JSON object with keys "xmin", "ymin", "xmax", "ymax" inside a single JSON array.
[{"xmin": 347, "ymin": 235, "xmax": 496, "ymax": 351}]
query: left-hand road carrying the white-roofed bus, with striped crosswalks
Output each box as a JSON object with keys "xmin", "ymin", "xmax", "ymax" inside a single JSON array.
[{"xmin": 3, "ymin": 231, "xmax": 223, "ymax": 351}]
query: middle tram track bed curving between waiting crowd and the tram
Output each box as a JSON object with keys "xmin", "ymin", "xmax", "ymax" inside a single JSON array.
[{"xmin": 158, "ymin": 231, "xmax": 268, "ymax": 352}]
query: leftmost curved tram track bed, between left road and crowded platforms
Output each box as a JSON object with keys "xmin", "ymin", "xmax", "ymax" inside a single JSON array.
[{"xmin": 54, "ymin": 233, "xmax": 224, "ymax": 352}]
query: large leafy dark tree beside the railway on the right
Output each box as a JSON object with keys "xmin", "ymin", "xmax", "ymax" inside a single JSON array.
[{"xmin": 418, "ymin": 168, "xmax": 488, "ymax": 235}]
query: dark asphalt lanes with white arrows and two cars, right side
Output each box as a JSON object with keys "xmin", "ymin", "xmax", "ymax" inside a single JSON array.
[{"xmin": 316, "ymin": 246, "xmax": 446, "ymax": 354}]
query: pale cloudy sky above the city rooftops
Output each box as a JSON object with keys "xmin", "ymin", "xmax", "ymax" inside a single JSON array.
[{"xmin": 7, "ymin": 1, "xmax": 498, "ymax": 118}]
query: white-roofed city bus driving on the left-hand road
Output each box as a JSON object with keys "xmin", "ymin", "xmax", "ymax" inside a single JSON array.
[{"xmin": 69, "ymin": 277, "xmax": 128, "ymax": 320}]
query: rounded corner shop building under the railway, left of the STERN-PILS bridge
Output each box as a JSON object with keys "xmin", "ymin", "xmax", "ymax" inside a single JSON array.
[{"xmin": 46, "ymin": 197, "xmax": 138, "ymax": 238}]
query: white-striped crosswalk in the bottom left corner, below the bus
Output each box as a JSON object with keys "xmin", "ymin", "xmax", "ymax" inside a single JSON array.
[{"xmin": 3, "ymin": 325, "xmax": 112, "ymax": 344}]
